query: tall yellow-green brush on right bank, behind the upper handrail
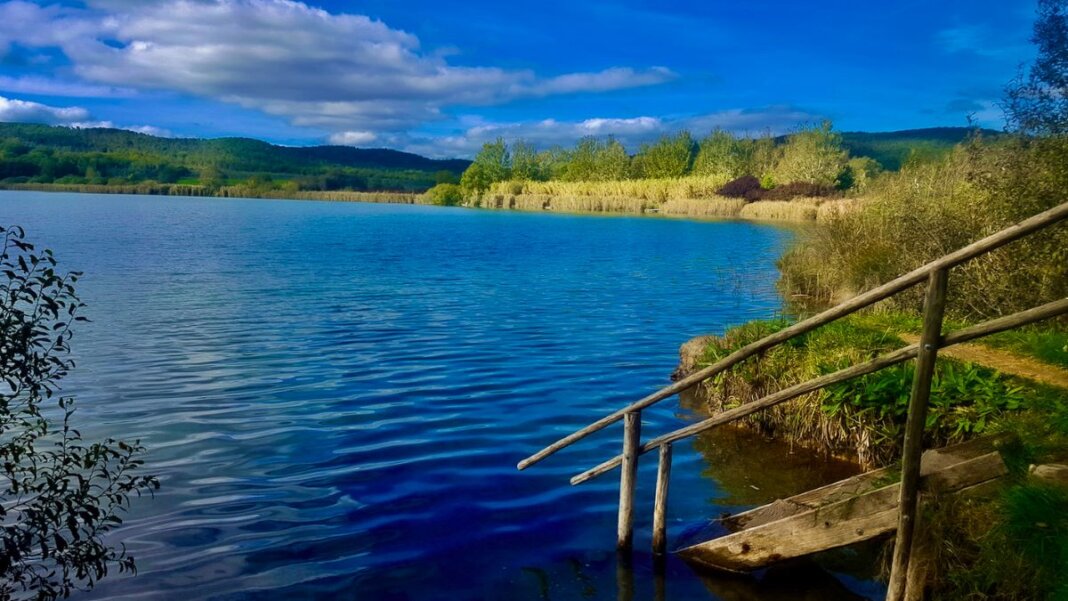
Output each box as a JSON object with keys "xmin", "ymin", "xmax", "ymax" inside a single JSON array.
[{"xmin": 780, "ymin": 138, "xmax": 1068, "ymax": 319}]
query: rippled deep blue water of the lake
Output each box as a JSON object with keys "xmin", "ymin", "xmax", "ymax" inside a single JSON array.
[{"xmin": 0, "ymin": 192, "xmax": 875, "ymax": 601}]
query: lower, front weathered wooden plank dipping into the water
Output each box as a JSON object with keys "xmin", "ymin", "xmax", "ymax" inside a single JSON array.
[{"xmin": 678, "ymin": 453, "xmax": 1007, "ymax": 571}]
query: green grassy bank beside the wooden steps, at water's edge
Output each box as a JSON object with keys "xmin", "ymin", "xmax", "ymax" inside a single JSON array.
[{"xmin": 688, "ymin": 314, "xmax": 1068, "ymax": 600}]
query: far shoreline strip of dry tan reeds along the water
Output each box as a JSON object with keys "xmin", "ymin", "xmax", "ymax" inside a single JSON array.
[{"xmin": 0, "ymin": 184, "xmax": 857, "ymax": 223}]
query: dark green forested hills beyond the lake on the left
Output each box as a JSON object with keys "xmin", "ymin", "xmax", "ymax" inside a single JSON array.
[{"xmin": 0, "ymin": 123, "xmax": 470, "ymax": 191}]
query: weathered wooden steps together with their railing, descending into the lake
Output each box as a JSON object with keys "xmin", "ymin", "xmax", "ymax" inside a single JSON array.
[{"xmin": 518, "ymin": 203, "xmax": 1068, "ymax": 601}]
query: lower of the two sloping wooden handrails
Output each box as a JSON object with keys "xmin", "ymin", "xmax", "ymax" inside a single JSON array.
[{"xmin": 571, "ymin": 298, "xmax": 1068, "ymax": 485}]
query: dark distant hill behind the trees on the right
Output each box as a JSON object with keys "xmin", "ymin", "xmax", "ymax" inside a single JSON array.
[{"xmin": 842, "ymin": 127, "xmax": 1001, "ymax": 171}]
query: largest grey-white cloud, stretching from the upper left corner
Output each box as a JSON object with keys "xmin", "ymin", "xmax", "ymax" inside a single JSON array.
[{"xmin": 0, "ymin": 0, "xmax": 675, "ymax": 131}]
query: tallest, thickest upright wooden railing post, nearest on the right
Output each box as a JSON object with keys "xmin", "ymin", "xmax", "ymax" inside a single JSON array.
[{"xmin": 886, "ymin": 269, "xmax": 948, "ymax": 601}]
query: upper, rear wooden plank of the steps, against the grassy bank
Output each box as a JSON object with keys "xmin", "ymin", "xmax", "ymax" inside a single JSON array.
[{"xmin": 722, "ymin": 437, "xmax": 1005, "ymax": 532}]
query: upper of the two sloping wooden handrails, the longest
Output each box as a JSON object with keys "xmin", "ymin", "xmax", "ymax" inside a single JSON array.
[{"xmin": 517, "ymin": 203, "xmax": 1068, "ymax": 471}]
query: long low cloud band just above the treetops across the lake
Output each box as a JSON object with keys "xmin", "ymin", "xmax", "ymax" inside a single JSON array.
[{"xmin": 391, "ymin": 107, "xmax": 821, "ymax": 157}]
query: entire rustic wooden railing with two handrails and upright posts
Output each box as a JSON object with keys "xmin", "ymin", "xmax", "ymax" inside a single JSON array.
[{"xmin": 518, "ymin": 203, "xmax": 1068, "ymax": 601}]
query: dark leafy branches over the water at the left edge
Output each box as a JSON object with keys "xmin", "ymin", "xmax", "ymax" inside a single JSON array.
[{"xmin": 0, "ymin": 227, "xmax": 159, "ymax": 599}]
